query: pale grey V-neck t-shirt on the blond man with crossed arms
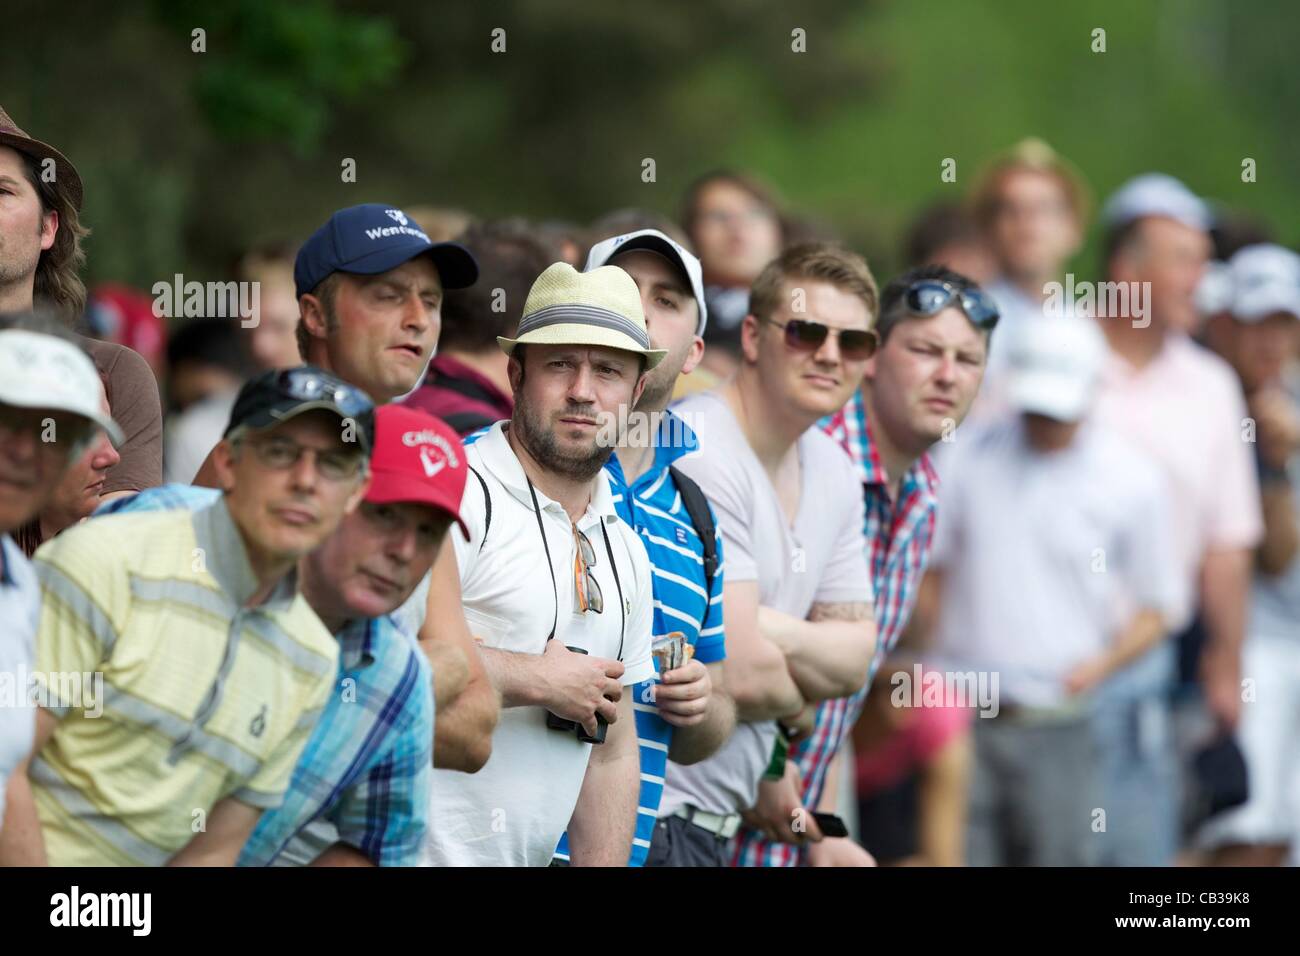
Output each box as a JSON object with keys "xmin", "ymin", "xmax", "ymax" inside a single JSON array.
[{"xmin": 659, "ymin": 392, "xmax": 871, "ymax": 817}]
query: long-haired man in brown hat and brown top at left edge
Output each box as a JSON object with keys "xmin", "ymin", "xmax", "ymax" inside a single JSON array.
[{"xmin": 0, "ymin": 108, "xmax": 163, "ymax": 498}]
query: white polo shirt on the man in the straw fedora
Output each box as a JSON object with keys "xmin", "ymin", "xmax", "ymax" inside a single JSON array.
[{"xmin": 423, "ymin": 421, "xmax": 655, "ymax": 866}]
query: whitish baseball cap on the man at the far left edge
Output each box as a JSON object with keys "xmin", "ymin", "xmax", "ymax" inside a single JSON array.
[{"xmin": 0, "ymin": 329, "xmax": 125, "ymax": 446}]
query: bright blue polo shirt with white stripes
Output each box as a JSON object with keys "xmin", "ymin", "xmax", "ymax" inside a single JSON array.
[{"xmin": 555, "ymin": 412, "xmax": 727, "ymax": 866}]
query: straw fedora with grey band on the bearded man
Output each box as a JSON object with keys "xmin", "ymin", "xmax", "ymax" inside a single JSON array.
[{"xmin": 497, "ymin": 263, "xmax": 668, "ymax": 369}]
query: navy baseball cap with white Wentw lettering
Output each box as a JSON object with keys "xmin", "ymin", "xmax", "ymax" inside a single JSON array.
[{"xmin": 294, "ymin": 203, "xmax": 478, "ymax": 298}]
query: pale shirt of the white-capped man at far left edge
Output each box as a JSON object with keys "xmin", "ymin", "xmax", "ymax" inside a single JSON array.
[{"xmin": 0, "ymin": 535, "xmax": 40, "ymax": 825}]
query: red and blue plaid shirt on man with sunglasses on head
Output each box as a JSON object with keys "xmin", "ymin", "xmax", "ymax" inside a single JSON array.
[{"xmin": 732, "ymin": 389, "xmax": 939, "ymax": 866}]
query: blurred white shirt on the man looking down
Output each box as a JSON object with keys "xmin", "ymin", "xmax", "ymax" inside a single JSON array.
[{"xmin": 931, "ymin": 414, "xmax": 1186, "ymax": 708}]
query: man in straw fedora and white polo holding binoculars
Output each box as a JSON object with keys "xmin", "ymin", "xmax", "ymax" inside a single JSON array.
[{"xmin": 424, "ymin": 263, "xmax": 666, "ymax": 866}]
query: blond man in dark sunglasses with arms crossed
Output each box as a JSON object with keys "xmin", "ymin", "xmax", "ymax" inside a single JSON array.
[{"xmin": 651, "ymin": 243, "xmax": 879, "ymax": 866}]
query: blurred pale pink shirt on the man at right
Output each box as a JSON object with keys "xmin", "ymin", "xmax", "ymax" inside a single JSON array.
[{"xmin": 1095, "ymin": 334, "xmax": 1264, "ymax": 630}]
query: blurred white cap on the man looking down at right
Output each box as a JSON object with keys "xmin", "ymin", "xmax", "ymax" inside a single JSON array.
[{"xmin": 1008, "ymin": 316, "xmax": 1106, "ymax": 421}]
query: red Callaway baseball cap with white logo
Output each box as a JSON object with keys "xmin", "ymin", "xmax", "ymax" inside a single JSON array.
[{"xmin": 365, "ymin": 405, "xmax": 469, "ymax": 537}]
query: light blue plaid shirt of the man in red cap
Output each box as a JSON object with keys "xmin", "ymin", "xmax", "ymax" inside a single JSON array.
[{"xmin": 95, "ymin": 485, "xmax": 434, "ymax": 866}]
